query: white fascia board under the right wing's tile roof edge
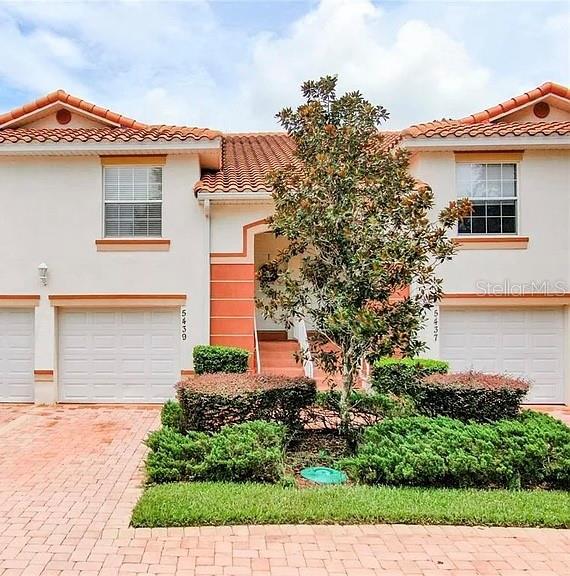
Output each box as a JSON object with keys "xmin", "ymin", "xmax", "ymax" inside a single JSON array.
[{"xmin": 400, "ymin": 136, "xmax": 570, "ymax": 150}]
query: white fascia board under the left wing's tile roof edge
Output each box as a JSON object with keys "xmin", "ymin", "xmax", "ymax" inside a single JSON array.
[{"xmin": 0, "ymin": 138, "xmax": 221, "ymax": 156}]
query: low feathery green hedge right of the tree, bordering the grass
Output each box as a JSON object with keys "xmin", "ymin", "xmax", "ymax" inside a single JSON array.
[{"xmin": 340, "ymin": 411, "xmax": 570, "ymax": 490}]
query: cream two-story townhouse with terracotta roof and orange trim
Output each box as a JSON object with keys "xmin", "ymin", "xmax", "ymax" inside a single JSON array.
[{"xmin": 0, "ymin": 83, "xmax": 570, "ymax": 403}]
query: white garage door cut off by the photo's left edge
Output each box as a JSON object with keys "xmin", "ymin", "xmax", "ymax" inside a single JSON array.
[{"xmin": 0, "ymin": 309, "xmax": 34, "ymax": 402}]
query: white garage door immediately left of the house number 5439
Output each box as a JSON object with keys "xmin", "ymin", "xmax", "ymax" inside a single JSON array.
[{"xmin": 58, "ymin": 309, "xmax": 180, "ymax": 402}]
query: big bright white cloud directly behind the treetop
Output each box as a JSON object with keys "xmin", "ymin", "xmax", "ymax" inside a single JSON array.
[{"xmin": 233, "ymin": 0, "xmax": 491, "ymax": 126}]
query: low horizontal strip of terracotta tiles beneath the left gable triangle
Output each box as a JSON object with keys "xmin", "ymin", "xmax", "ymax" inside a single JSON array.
[{"xmin": 0, "ymin": 125, "xmax": 221, "ymax": 144}]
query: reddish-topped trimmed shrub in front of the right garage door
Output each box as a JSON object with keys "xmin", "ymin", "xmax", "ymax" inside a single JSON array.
[{"xmin": 408, "ymin": 372, "xmax": 529, "ymax": 422}]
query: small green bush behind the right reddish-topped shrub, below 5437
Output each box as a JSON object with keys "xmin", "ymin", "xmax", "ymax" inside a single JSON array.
[{"xmin": 371, "ymin": 358, "xmax": 449, "ymax": 395}]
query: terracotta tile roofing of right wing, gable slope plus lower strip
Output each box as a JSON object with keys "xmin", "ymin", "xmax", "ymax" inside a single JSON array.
[{"xmin": 402, "ymin": 82, "xmax": 570, "ymax": 138}]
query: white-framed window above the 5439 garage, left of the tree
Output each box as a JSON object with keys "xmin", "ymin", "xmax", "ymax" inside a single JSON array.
[{"xmin": 103, "ymin": 165, "xmax": 162, "ymax": 238}]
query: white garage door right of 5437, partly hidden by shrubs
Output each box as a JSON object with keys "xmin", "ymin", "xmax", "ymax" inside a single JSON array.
[{"xmin": 440, "ymin": 308, "xmax": 564, "ymax": 404}]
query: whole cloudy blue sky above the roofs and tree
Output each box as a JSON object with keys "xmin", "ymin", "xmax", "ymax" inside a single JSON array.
[{"xmin": 0, "ymin": 0, "xmax": 570, "ymax": 131}]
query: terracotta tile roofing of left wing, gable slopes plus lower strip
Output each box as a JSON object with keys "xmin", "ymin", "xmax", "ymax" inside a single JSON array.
[{"xmin": 0, "ymin": 90, "xmax": 221, "ymax": 143}]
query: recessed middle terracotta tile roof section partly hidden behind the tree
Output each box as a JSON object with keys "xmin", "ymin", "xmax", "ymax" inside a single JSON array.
[{"xmin": 194, "ymin": 132, "xmax": 400, "ymax": 192}]
